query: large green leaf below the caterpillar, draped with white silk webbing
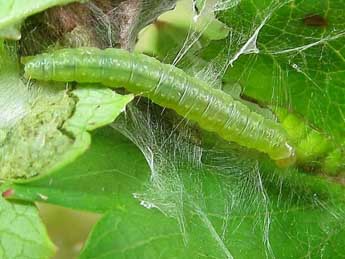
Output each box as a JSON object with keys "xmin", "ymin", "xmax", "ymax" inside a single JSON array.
[{"xmin": 10, "ymin": 124, "xmax": 345, "ymax": 258}]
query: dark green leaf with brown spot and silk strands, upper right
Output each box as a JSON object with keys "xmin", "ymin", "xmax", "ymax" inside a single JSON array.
[{"xmin": 214, "ymin": 0, "xmax": 345, "ymax": 140}]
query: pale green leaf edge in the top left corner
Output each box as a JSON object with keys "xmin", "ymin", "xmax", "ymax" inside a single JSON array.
[{"xmin": 0, "ymin": 0, "xmax": 82, "ymax": 39}]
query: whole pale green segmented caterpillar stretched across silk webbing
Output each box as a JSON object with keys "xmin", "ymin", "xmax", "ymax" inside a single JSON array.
[{"xmin": 24, "ymin": 48, "xmax": 295, "ymax": 163}]
